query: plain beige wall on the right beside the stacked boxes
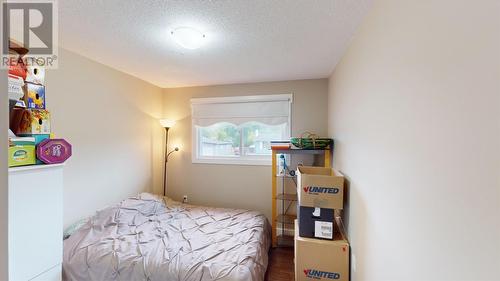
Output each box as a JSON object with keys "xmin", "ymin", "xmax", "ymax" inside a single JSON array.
[{"xmin": 329, "ymin": 0, "xmax": 500, "ymax": 281}]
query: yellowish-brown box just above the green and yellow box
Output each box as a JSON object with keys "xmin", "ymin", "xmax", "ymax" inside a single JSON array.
[{"xmin": 17, "ymin": 109, "xmax": 50, "ymax": 136}]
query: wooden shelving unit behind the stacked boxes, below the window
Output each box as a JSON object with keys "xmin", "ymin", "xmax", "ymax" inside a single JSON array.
[{"xmin": 272, "ymin": 149, "xmax": 331, "ymax": 247}]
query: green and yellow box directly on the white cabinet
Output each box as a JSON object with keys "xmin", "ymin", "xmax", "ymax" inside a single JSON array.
[{"xmin": 9, "ymin": 137, "xmax": 36, "ymax": 167}]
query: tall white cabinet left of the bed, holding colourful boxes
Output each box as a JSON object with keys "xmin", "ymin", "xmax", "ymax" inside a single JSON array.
[{"xmin": 9, "ymin": 165, "xmax": 63, "ymax": 281}]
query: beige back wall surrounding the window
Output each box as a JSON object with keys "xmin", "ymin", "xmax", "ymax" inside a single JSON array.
[{"xmin": 163, "ymin": 79, "xmax": 328, "ymax": 218}]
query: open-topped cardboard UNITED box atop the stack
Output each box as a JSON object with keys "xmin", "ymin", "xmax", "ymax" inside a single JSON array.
[{"xmin": 297, "ymin": 166, "xmax": 344, "ymax": 209}]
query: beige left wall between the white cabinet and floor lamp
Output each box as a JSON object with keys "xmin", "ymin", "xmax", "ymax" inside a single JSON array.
[{"xmin": 46, "ymin": 49, "xmax": 163, "ymax": 226}]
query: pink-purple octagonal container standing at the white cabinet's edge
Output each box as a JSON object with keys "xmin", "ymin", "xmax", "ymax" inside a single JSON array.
[{"xmin": 36, "ymin": 139, "xmax": 72, "ymax": 164}]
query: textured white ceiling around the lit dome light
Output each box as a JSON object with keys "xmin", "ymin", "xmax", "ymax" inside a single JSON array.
[{"xmin": 58, "ymin": 0, "xmax": 371, "ymax": 87}]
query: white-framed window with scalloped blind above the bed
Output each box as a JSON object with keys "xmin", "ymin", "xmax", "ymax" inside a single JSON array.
[{"xmin": 191, "ymin": 95, "xmax": 292, "ymax": 165}]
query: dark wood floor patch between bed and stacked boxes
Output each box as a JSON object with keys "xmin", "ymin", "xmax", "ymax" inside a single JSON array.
[{"xmin": 266, "ymin": 248, "xmax": 295, "ymax": 281}]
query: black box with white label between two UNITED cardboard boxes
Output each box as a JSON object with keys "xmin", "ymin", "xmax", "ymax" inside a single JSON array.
[{"xmin": 297, "ymin": 206, "xmax": 338, "ymax": 240}]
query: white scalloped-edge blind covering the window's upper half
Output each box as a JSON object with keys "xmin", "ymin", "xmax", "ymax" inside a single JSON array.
[{"xmin": 191, "ymin": 94, "xmax": 292, "ymax": 126}]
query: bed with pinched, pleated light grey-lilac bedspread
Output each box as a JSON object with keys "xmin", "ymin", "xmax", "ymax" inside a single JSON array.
[{"xmin": 63, "ymin": 193, "xmax": 270, "ymax": 281}]
